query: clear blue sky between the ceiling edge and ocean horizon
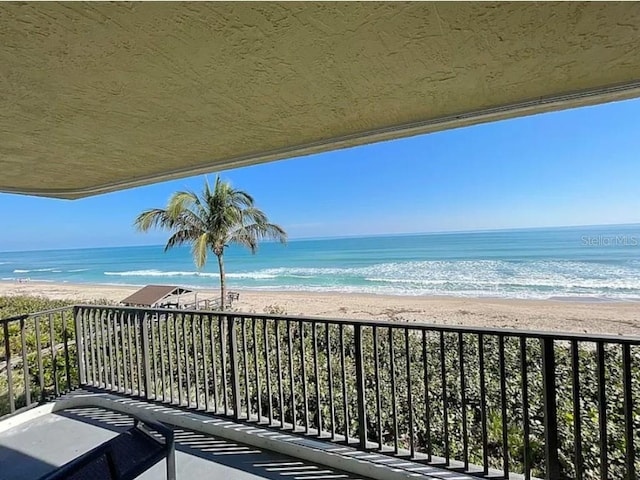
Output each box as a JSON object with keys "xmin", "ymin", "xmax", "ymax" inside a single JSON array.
[{"xmin": 0, "ymin": 100, "xmax": 640, "ymax": 251}]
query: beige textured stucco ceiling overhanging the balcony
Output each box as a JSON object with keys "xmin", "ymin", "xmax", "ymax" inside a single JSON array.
[{"xmin": 0, "ymin": 2, "xmax": 640, "ymax": 198}]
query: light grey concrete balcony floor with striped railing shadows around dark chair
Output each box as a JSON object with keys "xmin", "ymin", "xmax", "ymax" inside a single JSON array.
[{"xmin": 0, "ymin": 407, "xmax": 363, "ymax": 480}]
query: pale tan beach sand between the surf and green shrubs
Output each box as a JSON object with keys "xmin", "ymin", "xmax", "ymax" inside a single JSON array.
[{"xmin": 0, "ymin": 282, "xmax": 640, "ymax": 336}]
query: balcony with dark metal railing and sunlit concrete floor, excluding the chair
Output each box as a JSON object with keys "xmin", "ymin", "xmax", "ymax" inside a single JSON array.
[{"xmin": 0, "ymin": 305, "xmax": 640, "ymax": 479}]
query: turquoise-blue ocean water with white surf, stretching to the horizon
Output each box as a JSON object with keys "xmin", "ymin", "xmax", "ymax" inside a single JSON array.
[{"xmin": 0, "ymin": 225, "xmax": 640, "ymax": 300}]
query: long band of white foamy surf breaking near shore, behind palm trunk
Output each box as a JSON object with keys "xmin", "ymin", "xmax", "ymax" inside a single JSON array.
[{"xmin": 97, "ymin": 260, "xmax": 640, "ymax": 299}]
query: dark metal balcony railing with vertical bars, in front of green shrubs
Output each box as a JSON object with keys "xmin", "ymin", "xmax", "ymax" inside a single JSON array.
[{"xmin": 0, "ymin": 305, "xmax": 640, "ymax": 479}]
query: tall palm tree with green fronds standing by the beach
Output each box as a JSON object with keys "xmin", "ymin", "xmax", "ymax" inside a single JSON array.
[{"xmin": 134, "ymin": 177, "xmax": 287, "ymax": 310}]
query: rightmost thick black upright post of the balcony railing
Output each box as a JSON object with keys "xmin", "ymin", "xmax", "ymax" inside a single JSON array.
[{"xmin": 541, "ymin": 338, "xmax": 560, "ymax": 480}]
